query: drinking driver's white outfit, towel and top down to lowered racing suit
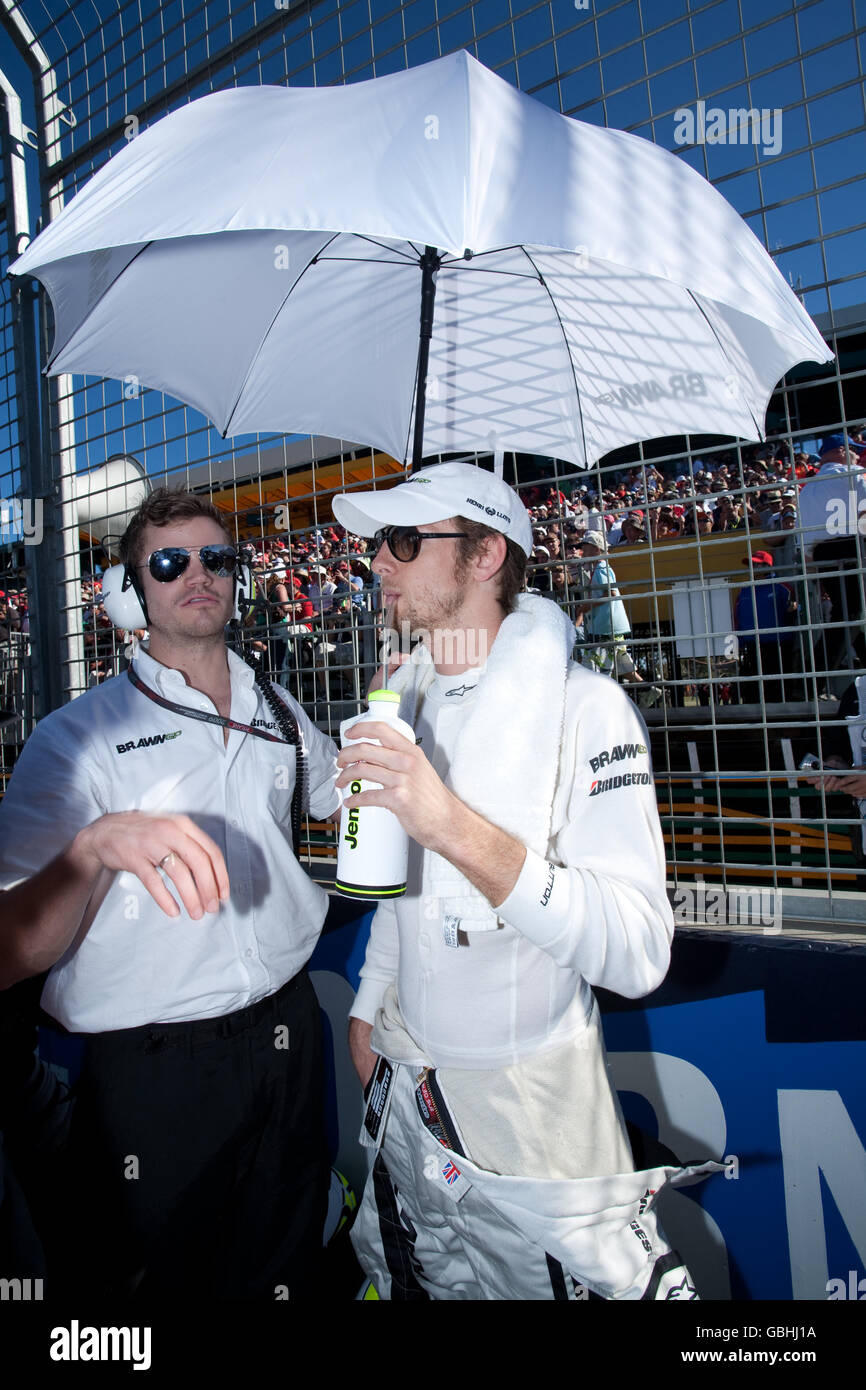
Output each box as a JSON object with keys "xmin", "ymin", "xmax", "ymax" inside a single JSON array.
[{"xmin": 352, "ymin": 595, "xmax": 720, "ymax": 1300}]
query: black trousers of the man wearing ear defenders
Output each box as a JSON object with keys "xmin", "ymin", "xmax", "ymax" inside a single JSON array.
[{"xmin": 52, "ymin": 970, "xmax": 329, "ymax": 1301}]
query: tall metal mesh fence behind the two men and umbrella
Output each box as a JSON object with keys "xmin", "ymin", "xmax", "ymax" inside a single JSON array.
[{"xmin": 0, "ymin": 0, "xmax": 866, "ymax": 930}]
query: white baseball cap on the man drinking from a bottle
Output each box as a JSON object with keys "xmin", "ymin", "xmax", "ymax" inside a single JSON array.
[{"xmin": 332, "ymin": 460, "xmax": 532, "ymax": 555}]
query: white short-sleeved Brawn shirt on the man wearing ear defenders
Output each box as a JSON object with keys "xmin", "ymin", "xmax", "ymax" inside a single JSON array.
[{"xmin": 0, "ymin": 649, "xmax": 341, "ymax": 1033}]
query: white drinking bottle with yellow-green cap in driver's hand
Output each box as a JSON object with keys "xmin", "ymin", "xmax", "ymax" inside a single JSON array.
[{"xmin": 335, "ymin": 691, "xmax": 416, "ymax": 898}]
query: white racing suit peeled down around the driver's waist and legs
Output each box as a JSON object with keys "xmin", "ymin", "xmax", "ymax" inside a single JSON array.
[{"xmin": 352, "ymin": 1013, "xmax": 724, "ymax": 1301}]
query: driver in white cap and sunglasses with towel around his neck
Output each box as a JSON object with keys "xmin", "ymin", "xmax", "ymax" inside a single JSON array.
[{"xmin": 334, "ymin": 463, "xmax": 695, "ymax": 1300}]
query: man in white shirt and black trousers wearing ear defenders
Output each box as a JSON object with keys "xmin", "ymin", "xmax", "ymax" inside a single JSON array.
[{"xmin": 0, "ymin": 489, "xmax": 339, "ymax": 1301}]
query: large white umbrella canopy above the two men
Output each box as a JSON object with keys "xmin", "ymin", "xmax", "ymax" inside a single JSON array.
[{"xmin": 11, "ymin": 53, "xmax": 833, "ymax": 464}]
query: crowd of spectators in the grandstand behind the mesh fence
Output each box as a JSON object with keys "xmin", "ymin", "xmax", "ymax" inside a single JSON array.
[{"xmin": 0, "ymin": 427, "xmax": 866, "ymax": 703}]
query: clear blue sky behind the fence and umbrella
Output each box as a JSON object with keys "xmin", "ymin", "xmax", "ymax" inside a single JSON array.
[{"xmin": 0, "ymin": 0, "xmax": 866, "ymax": 492}]
